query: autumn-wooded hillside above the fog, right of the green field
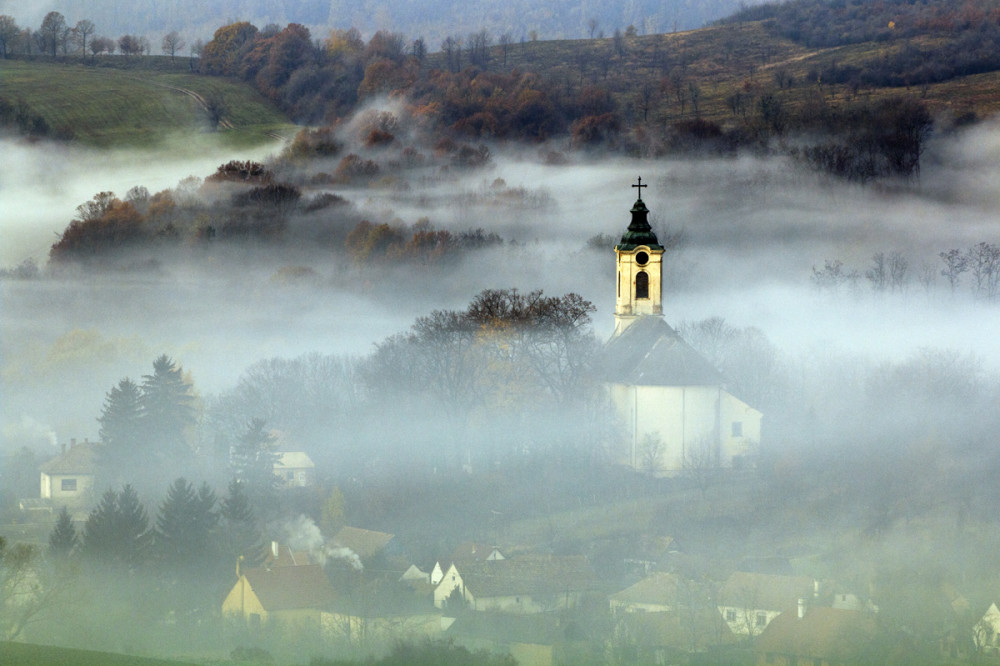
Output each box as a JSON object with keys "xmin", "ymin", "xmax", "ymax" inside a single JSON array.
[{"xmin": 0, "ymin": 0, "xmax": 1000, "ymax": 174}]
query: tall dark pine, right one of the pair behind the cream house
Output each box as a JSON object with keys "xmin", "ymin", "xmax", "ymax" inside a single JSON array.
[{"xmin": 141, "ymin": 354, "xmax": 195, "ymax": 462}]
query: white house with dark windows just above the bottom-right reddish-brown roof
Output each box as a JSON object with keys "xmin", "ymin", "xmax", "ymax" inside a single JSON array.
[{"xmin": 716, "ymin": 571, "xmax": 816, "ymax": 638}]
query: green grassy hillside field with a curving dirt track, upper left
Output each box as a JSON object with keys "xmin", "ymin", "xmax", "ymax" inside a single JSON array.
[{"xmin": 0, "ymin": 60, "xmax": 295, "ymax": 147}]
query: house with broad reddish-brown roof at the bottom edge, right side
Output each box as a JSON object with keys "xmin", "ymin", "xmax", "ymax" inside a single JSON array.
[{"xmin": 754, "ymin": 603, "xmax": 877, "ymax": 666}]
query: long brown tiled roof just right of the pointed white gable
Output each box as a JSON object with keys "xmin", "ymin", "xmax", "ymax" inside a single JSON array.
[{"xmin": 457, "ymin": 556, "xmax": 598, "ymax": 599}]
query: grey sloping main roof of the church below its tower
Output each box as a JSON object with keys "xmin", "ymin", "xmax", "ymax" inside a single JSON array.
[{"xmin": 602, "ymin": 315, "xmax": 723, "ymax": 386}]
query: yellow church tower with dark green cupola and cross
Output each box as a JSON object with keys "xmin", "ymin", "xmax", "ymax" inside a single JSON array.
[{"xmin": 611, "ymin": 178, "xmax": 663, "ymax": 338}]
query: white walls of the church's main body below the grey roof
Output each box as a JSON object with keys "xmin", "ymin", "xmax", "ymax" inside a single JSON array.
[{"xmin": 610, "ymin": 384, "xmax": 762, "ymax": 473}]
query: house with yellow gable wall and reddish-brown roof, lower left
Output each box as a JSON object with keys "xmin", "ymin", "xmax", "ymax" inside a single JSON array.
[{"xmin": 222, "ymin": 564, "xmax": 336, "ymax": 632}]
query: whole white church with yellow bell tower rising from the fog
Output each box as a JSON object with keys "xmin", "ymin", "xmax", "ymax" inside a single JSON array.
[{"xmin": 602, "ymin": 178, "xmax": 763, "ymax": 475}]
